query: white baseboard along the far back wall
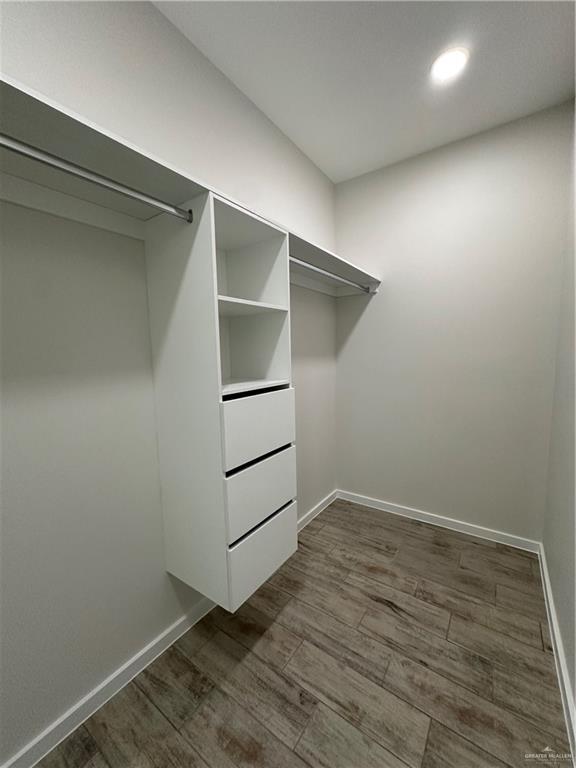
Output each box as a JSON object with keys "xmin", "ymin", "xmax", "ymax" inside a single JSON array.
[{"xmin": 336, "ymin": 491, "xmax": 540, "ymax": 553}]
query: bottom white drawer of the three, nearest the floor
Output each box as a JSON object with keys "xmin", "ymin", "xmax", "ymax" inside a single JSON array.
[{"xmin": 228, "ymin": 501, "xmax": 298, "ymax": 611}]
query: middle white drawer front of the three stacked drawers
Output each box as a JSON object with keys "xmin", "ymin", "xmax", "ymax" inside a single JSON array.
[{"xmin": 226, "ymin": 448, "xmax": 296, "ymax": 544}]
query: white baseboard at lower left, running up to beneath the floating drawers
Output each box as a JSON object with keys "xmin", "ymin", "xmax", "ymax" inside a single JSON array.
[{"xmin": 0, "ymin": 597, "xmax": 214, "ymax": 768}]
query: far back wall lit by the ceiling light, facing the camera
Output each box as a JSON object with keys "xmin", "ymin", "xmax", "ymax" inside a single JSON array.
[{"xmin": 336, "ymin": 105, "xmax": 571, "ymax": 539}]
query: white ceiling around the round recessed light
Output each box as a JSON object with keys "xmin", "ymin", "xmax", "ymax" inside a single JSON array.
[{"xmin": 157, "ymin": 0, "xmax": 574, "ymax": 182}]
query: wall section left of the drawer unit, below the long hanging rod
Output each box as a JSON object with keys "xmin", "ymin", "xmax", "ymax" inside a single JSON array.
[{"xmin": 0, "ymin": 203, "xmax": 198, "ymax": 763}]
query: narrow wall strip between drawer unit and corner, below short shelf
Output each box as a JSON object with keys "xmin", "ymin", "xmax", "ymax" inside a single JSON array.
[{"xmin": 290, "ymin": 285, "xmax": 336, "ymax": 517}]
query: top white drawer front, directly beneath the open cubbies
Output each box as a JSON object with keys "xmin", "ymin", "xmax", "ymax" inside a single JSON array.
[{"xmin": 221, "ymin": 389, "xmax": 295, "ymax": 471}]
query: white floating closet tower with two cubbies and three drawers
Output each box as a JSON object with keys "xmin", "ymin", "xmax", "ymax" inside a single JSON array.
[{"xmin": 146, "ymin": 192, "xmax": 297, "ymax": 611}]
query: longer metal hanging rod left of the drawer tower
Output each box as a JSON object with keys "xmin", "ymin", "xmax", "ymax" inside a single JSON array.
[{"xmin": 0, "ymin": 133, "xmax": 192, "ymax": 222}]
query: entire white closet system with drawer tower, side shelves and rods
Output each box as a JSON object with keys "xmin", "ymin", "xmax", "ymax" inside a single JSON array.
[{"xmin": 0, "ymin": 81, "xmax": 379, "ymax": 611}]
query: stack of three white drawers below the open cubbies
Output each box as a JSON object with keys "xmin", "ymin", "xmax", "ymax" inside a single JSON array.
[{"xmin": 221, "ymin": 389, "xmax": 297, "ymax": 610}]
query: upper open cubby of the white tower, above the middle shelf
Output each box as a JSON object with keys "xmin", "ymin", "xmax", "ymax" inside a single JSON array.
[{"xmin": 214, "ymin": 200, "xmax": 289, "ymax": 309}]
